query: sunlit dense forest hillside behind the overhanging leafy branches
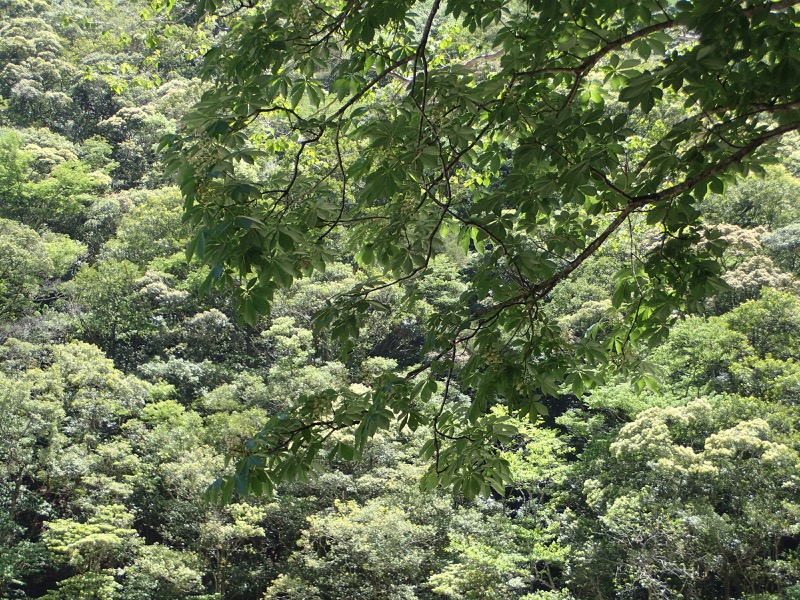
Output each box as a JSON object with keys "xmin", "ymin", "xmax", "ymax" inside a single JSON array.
[{"xmin": 0, "ymin": 0, "xmax": 800, "ymax": 600}]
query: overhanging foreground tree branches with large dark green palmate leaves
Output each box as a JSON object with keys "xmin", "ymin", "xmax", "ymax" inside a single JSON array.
[{"xmin": 162, "ymin": 0, "xmax": 800, "ymax": 497}]
